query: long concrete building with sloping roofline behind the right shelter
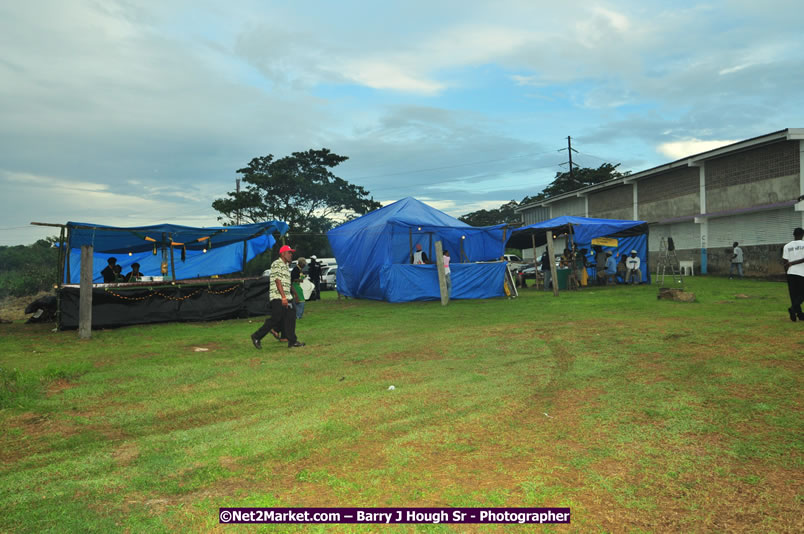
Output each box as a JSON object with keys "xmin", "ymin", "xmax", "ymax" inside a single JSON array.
[{"xmin": 516, "ymin": 128, "xmax": 804, "ymax": 276}]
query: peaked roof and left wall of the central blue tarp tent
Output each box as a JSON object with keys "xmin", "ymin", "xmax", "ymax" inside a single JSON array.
[{"xmin": 327, "ymin": 197, "xmax": 505, "ymax": 300}]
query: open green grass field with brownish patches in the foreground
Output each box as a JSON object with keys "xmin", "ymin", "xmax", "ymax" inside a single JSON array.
[{"xmin": 0, "ymin": 278, "xmax": 804, "ymax": 532}]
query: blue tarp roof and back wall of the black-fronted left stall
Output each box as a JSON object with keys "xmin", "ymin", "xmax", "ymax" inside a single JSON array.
[{"xmin": 64, "ymin": 221, "xmax": 288, "ymax": 284}]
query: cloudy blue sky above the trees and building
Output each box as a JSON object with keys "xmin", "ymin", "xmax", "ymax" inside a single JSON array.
[{"xmin": 0, "ymin": 0, "xmax": 804, "ymax": 245}]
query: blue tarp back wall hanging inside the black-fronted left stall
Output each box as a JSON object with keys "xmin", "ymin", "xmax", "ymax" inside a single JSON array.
[{"xmin": 64, "ymin": 235, "xmax": 276, "ymax": 284}]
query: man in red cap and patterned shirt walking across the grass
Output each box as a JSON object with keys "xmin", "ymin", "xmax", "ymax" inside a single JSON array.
[{"xmin": 251, "ymin": 245, "xmax": 304, "ymax": 349}]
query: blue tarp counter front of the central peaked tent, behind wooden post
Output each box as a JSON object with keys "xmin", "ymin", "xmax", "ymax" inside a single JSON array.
[{"xmin": 380, "ymin": 262, "xmax": 506, "ymax": 302}]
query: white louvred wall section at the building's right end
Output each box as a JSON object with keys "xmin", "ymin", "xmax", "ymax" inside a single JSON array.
[{"xmin": 708, "ymin": 207, "xmax": 801, "ymax": 248}]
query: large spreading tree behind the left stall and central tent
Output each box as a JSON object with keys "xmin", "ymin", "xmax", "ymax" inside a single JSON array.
[{"xmin": 212, "ymin": 148, "xmax": 381, "ymax": 255}]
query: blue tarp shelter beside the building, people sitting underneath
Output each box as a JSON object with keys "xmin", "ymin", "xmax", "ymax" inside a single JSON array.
[{"xmin": 507, "ymin": 216, "xmax": 650, "ymax": 282}]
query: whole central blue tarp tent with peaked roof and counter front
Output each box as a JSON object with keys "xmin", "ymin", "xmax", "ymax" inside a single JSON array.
[{"xmin": 327, "ymin": 197, "xmax": 505, "ymax": 302}]
